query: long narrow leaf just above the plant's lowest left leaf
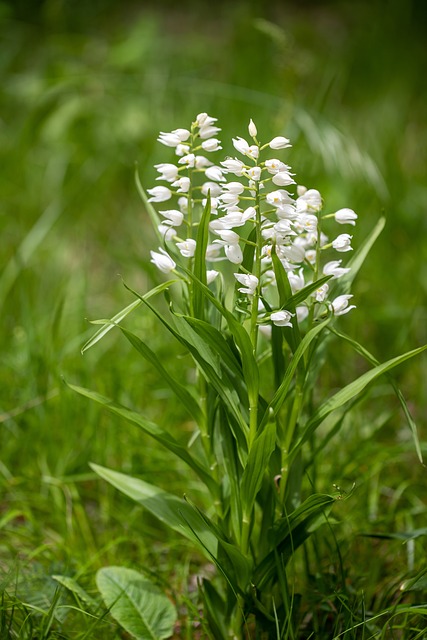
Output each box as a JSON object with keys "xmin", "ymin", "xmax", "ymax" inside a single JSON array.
[{"xmin": 67, "ymin": 383, "xmax": 218, "ymax": 496}]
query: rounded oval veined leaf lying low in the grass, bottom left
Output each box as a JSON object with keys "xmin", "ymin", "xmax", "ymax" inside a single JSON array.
[{"xmin": 96, "ymin": 567, "xmax": 177, "ymax": 640}]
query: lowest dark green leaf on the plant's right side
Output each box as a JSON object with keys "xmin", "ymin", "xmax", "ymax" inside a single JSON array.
[{"xmin": 252, "ymin": 494, "xmax": 336, "ymax": 592}]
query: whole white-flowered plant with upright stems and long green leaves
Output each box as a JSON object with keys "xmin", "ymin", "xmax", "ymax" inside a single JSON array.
[{"xmin": 74, "ymin": 113, "xmax": 423, "ymax": 640}]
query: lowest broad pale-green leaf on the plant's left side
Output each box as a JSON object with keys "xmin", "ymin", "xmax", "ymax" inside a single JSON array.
[{"xmin": 90, "ymin": 464, "xmax": 218, "ymax": 559}]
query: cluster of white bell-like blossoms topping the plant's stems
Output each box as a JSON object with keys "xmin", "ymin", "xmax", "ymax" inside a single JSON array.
[{"xmin": 148, "ymin": 113, "xmax": 357, "ymax": 326}]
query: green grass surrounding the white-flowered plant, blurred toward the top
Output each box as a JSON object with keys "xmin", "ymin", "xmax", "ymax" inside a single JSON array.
[{"xmin": 0, "ymin": 1, "xmax": 427, "ymax": 640}]
